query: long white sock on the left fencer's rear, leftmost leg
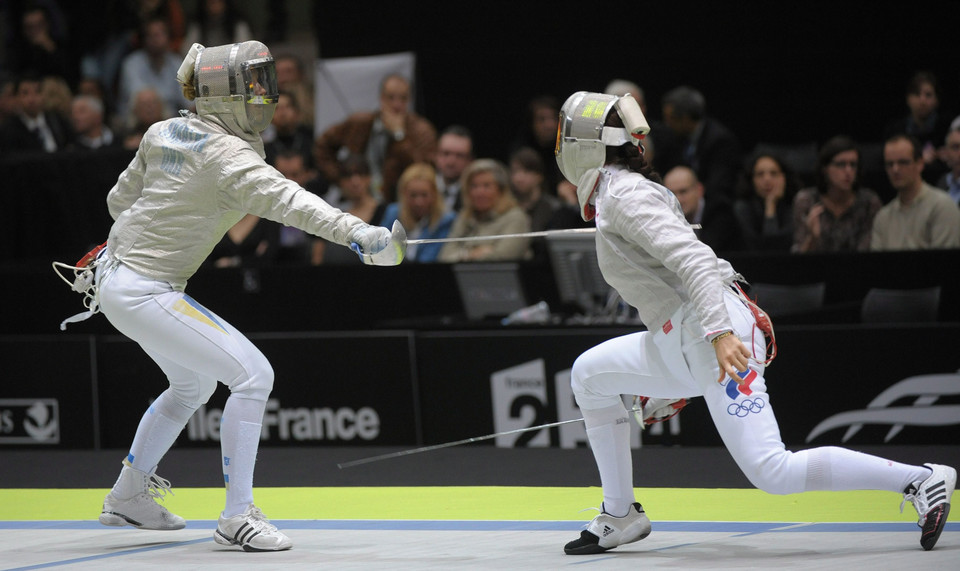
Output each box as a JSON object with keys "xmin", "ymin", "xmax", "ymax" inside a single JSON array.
[{"xmin": 124, "ymin": 389, "xmax": 196, "ymax": 474}]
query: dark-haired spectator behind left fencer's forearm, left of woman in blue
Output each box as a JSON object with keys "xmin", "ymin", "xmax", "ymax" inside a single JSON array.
[{"xmin": 311, "ymin": 155, "xmax": 386, "ymax": 265}]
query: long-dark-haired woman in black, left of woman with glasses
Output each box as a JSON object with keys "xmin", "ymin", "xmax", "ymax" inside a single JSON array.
[{"xmin": 733, "ymin": 153, "xmax": 800, "ymax": 252}]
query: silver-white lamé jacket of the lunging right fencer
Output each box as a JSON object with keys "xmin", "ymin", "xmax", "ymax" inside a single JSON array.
[{"xmin": 596, "ymin": 166, "xmax": 739, "ymax": 338}]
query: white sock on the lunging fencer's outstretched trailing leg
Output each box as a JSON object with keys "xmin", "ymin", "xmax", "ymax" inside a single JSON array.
[{"xmin": 806, "ymin": 446, "xmax": 930, "ymax": 493}]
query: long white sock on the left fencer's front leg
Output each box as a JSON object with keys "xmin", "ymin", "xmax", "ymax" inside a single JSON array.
[{"xmin": 220, "ymin": 395, "xmax": 267, "ymax": 517}]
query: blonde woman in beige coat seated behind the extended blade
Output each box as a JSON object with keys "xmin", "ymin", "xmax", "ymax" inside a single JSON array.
[{"xmin": 438, "ymin": 159, "xmax": 530, "ymax": 262}]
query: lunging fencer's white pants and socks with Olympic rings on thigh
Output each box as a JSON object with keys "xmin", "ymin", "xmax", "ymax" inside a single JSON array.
[{"xmin": 571, "ymin": 291, "xmax": 929, "ymax": 512}]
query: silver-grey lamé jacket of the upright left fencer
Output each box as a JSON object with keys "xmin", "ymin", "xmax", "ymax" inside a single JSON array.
[{"xmin": 107, "ymin": 114, "xmax": 363, "ymax": 290}]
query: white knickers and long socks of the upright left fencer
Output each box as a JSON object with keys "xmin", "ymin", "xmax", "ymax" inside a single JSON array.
[{"xmin": 98, "ymin": 260, "xmax": 273, "ymax": 516}]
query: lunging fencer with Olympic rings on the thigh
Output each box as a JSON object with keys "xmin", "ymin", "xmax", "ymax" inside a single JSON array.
[{"xmin": 557, "ymin": 92, "xmax": 957, "ymax": 554}]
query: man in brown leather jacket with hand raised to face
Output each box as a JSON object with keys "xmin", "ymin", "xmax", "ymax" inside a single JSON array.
[{"xmin": 314, "ymin": 74, "xmax": 437, "ymax": 203}]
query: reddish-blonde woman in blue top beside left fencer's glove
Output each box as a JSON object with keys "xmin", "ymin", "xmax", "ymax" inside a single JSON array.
[{"xmin": 380, "ymin": 163, "xmax": 456, "ymax": 262}]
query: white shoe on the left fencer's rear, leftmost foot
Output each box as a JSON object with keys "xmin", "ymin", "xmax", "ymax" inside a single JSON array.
[{"xmin": 100, "ymin": 468, "xmax": 187, "ymax": 530}]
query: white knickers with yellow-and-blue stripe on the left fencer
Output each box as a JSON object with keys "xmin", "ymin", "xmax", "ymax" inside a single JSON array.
[{"xmin": 97, "ymin": 259, "xmax": 273, "ymax": 405}]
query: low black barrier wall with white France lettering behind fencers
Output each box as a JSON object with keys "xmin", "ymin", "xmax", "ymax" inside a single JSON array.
[{"xmin": 0, "ymin": 324, "xmax": 960, "ymax": 449}]
